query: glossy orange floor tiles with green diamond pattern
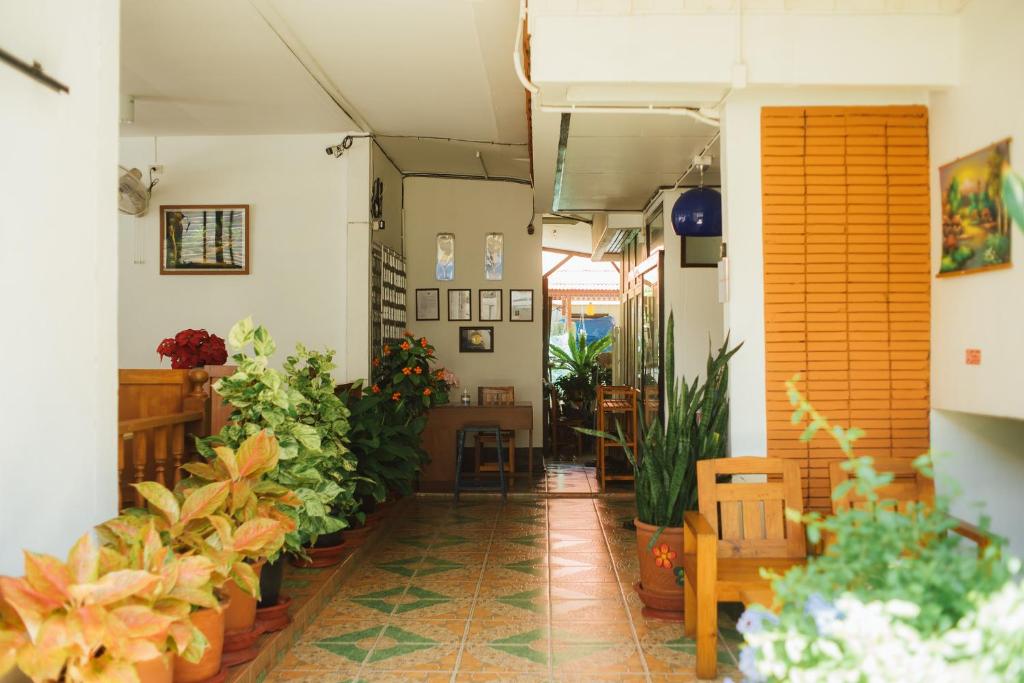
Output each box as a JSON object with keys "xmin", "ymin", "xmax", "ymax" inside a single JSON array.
[{"xmin": 267, "ymin": 497, "xmax": 739, "ymax": 683}]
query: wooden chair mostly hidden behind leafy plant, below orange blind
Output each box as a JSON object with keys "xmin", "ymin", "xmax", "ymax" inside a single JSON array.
[{"xmin": 828, "ymin": 458, "xmax": 991, "ymax": 555}]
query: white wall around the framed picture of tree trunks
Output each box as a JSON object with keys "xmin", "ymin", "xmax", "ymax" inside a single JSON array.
[{"xmin": 118, "ymin": 134, "xmax": 352, "ymax": 379}]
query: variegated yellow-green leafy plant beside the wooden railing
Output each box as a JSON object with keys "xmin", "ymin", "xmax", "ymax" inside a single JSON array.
[{"xmin": 199, "ymin": 317, "xmax": 347, "ymax": 548}]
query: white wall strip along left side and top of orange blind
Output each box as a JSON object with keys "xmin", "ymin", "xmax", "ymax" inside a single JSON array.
[{"xmin": 721, "ymin": 88, "xmax": 927, "ymax": 455}]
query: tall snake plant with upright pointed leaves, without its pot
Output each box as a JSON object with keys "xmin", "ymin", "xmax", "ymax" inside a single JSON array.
[{"xmin": 580, "ymin": 314, "xmax": 742, "ymax": 527}]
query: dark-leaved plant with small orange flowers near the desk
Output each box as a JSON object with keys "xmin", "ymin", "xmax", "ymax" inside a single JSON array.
[{"xmin": 370, "ymin": 330, "xmax": 449, "ymax": 418}]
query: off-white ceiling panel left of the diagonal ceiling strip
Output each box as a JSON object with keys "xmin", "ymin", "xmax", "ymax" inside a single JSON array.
[{"xmin": 121, "ymin": 0, "xmax": 354, "ymax": 136}]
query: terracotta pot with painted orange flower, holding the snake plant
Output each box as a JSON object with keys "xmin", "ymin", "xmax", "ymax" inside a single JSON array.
[{"xmin": 633, "ymin": 519, "xmax": 683, "ymax": 618}]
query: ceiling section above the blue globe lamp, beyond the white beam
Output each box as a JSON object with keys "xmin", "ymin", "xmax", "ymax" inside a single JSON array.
[{"xmin": 552, "ymin": 114, "xmax": 721, "ymax": 212}]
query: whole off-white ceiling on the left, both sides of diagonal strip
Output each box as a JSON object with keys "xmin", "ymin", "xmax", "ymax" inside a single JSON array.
[{"xmin": 121, "ymin": 0, "xmax": 529, "ymax": 178}]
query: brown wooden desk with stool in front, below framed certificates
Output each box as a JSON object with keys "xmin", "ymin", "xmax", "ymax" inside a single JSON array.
[{"xmin": 420, "ymin": 401, "xmax": 534, "ymax": 492}]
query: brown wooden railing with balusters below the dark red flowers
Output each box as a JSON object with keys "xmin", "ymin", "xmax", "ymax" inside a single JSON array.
[{"xmin": 118, "ymin": 369, "xmax": 210, "ymax": 508}]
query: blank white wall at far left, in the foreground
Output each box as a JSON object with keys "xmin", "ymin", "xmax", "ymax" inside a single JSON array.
[{"xmin": 0, "ymin": 0, "xmax": 118, "ymax": 574}]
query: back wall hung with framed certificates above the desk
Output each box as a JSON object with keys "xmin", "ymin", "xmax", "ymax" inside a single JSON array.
[{"xmin": 406, "ymin": 178, "xmax": 544, "ymax": 445}]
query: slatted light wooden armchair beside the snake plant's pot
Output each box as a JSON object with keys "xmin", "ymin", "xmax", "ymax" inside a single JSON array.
[{"xmin": 681, "ymin": 457, "xmax": 807, "ymax": 679}]
